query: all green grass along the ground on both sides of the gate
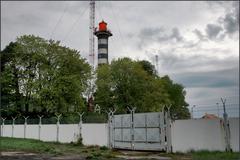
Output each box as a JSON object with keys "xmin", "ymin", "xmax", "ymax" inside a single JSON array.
[{"xmin": 0, "ymin": 137, "xmax": 240, "ymax": 160}]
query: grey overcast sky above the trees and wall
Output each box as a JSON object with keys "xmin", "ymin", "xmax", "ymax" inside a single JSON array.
[{"xmin": 1, "ymin": 1, "xmax": 239, "ymax": 118}]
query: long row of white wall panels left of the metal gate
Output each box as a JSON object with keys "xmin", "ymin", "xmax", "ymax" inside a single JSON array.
[{"xmin": 2, "ymin": 123, "xmax": 108, "ymax": 146}]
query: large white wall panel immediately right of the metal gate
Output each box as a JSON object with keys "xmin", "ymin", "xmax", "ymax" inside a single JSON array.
[{"xmin": 171, "ymin": 119, "xmax": 225, "ymax": 152}]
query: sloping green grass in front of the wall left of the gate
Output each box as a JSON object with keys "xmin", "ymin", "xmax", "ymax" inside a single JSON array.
[{"xmin": 0, "ymin": 137, "xmax": 117, "ymax": 160}]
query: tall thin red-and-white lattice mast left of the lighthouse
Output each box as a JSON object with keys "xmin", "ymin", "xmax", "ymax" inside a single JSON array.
[{"xmin": 89, "ymin": 0, "xmax": 95, "ymax": 69}]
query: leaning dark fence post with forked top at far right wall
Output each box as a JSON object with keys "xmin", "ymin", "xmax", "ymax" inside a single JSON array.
[{"xmin": 221, "ymin": 98, "xmax": 231, "ymax": 152}]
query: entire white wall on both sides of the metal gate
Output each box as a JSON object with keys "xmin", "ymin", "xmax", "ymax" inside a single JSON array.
[{"xmin": 1, "ymin": 118, "xmax": 239, "ymax": 152}]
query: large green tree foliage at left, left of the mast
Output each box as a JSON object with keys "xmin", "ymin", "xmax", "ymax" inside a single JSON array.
[{"xmin": 1, "ymin": 35, "xmax": 91, "ymax": 117}]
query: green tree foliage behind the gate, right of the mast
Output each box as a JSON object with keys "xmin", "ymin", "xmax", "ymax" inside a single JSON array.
[{"xmin": 95, "ymin": 58, "xmax": 190, "ymax": 119}]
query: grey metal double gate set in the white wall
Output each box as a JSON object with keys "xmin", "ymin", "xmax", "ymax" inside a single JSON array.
[{"xmin": 109, "ymin": 111, "xmax": 171, "ymax": 152}]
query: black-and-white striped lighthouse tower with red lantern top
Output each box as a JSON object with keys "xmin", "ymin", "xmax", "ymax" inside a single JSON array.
[{"xmin": 94, "ymin": 21, "xmax": 112, "ymax": 66}]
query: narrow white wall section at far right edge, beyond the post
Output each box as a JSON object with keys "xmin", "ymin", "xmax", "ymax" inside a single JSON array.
[{"xmin": 229, "ymin": 118, "xmax": 239, "ymax": 152}]
